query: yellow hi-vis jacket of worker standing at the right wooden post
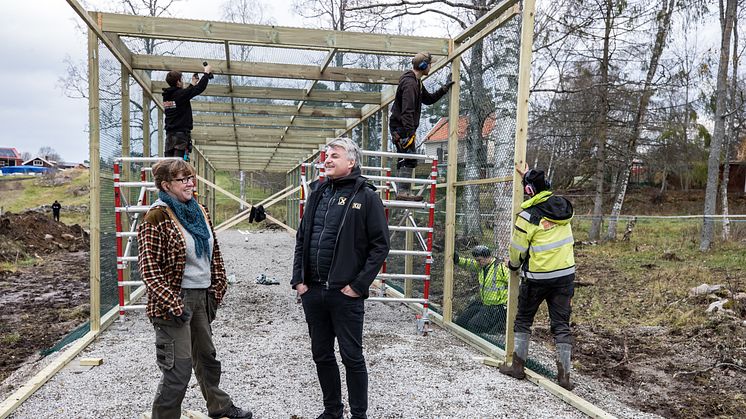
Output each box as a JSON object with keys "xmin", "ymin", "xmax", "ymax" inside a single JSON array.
[{"xmin": 510, "ymin": 191, "xmax": 575, "ymax": 285}]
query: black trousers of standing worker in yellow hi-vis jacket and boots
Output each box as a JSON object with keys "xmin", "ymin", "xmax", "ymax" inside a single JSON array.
[{"xmin": 513, "ymin": 279, "xmax": 575, "ymax": 344}]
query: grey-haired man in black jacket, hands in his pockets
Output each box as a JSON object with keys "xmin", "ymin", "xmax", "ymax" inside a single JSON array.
[{"xmin": 290, "ymin": 138, "xmax": 389, "ymax": 419}]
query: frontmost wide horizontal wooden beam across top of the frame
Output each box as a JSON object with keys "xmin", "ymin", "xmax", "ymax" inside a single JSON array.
[{"xmin": 101, "ymin": 13, "xmax": 448, "ymax": 55}]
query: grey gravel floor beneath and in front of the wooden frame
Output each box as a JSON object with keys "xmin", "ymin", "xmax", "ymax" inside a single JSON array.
[{"xmin": 11, "ymin": 231, "xmax": 648, "ymax": 419}]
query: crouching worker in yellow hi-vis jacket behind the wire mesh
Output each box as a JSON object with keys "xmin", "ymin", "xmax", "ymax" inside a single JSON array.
[{"xmin": 453, "ymin": 245, "xmax": 510, "ymax": 334}]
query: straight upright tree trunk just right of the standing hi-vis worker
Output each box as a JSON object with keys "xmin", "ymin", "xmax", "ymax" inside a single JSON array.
[{"xmin": 588, "ymin": 0, "xmax": 613, "ymax": 240}]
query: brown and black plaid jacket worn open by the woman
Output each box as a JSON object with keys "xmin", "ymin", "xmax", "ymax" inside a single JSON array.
[{"xmin": 137, "ymin": 205, "xmax": 227, "ymax": 319}]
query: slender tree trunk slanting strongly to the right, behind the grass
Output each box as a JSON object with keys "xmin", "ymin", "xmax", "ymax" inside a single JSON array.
[{"xmin": 606, "ymin": 0, "xmax": 675, "ymax": 240}]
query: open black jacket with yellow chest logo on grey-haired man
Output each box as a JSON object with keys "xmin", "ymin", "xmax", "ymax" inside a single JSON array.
[{"xmin": 290, "ymin": 167, "xmax": 389, "ymax": 298}]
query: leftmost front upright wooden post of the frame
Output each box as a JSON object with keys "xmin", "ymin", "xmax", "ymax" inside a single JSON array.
[{"xmin": 88, "ymin": 29, "xmax": 101, "ymax": 333}]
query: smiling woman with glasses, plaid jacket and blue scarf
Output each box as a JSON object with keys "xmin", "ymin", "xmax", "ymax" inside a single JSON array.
[{"xmin": 137, "ymin": 159, "xmax": 251, "ymax": 419}]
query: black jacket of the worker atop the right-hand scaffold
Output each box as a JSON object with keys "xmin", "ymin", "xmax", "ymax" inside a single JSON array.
[{"xmin": 389, "ymin": 70, "xmax": 448, "ymax": 138}]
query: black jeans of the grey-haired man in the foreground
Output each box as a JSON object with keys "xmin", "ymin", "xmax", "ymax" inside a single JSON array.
[{"xmin": 301, "ymin": 286, "xmax": 368, "ymax": 419}]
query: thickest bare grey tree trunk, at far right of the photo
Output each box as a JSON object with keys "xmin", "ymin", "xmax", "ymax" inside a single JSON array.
[{"xmin": 699, "ymin": 0, "xmax": 738, "ymax": 252}]
